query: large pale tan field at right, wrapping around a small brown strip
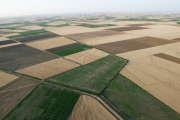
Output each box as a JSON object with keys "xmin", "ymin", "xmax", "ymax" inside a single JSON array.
[{"xmin": 118, "ymin": 43, "xmax": 180, "ymax": 113}]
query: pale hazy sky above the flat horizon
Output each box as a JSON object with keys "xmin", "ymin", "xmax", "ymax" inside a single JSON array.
[{"xmin": 0, "ymin": 0, "xmax": 180, "ymax": 17}]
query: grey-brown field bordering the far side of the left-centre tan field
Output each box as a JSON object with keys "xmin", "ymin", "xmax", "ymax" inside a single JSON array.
[{"xmin": 0, "ymin": 52, "xmax": 58, "ymax": 71}]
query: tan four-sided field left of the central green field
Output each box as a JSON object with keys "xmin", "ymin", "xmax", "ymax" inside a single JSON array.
[{"xmin": 16, "ymin": 58, "xmax": 80, "ymax": 79}]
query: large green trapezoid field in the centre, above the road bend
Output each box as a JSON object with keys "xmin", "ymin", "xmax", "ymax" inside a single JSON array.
[{"xmin": 46, "ymin": 55, "xmax": 126, "ymax": 94}]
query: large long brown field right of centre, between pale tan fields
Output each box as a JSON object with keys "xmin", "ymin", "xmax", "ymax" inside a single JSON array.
[{"xmin": 95, "ymin": 37, "xmax": 177, "ymax": 54}]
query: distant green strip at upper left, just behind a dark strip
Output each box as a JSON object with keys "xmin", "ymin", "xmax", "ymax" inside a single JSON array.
[{"xmin": 9, "ymin": 29, "xmax": 50, "ymax": 38}]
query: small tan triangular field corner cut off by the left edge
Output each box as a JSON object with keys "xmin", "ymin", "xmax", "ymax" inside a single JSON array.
[{"xmin": 0, "ymin": 71, "xmax": 18, "ymax": 87}]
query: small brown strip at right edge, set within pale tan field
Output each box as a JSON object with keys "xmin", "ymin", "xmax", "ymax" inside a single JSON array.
[{"xmin": 154, "ymin": 53, "xmax": 180, "ymax": 64}]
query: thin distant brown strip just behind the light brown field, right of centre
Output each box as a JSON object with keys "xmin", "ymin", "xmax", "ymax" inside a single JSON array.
[{"xmin": 107, "ymin": 27, "xmax": 148, "ymax": 32}]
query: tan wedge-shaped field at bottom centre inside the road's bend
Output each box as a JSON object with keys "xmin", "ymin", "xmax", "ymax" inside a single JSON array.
[{"xmin": 69, "ymin": 95, "xmax": 116, "ymax": 120}]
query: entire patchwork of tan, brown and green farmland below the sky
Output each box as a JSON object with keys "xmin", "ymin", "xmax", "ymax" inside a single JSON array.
[{"xmin": 0, "ymin": 13, "xmax": 180, "ymax": 120}]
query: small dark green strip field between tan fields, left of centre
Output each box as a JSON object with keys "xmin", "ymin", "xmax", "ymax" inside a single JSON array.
[{"xmin": 53, "ymin": 45, "xmax": 92, "ymax": 56}]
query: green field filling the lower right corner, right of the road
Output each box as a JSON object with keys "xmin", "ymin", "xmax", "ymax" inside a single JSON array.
[{"xmin": 102, "ymin": 75, "xmax": 180, "ymax": 120}]
